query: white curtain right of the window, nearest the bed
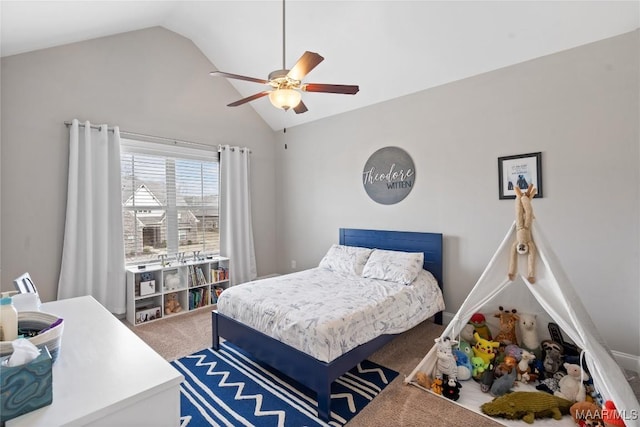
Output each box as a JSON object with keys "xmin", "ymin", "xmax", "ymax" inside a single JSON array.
[{"xmin": 220, "ymin": 145, "xmax": 257, "ymax": 285}]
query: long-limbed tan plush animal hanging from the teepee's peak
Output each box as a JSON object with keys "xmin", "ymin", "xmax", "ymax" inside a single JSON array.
[{"xmin": 509, "ymin": 184, "xmax": 536, "ymax": 283}]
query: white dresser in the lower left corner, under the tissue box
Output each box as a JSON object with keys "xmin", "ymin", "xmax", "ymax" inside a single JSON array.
[{"xmin": 6, "ymin": 296, "xmax": 183, "ymax": 427}]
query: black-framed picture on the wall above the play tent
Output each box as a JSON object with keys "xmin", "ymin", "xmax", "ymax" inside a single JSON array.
[{"xmin": 498, "ymin": 152, "xmax": 542, "ymax": 200}]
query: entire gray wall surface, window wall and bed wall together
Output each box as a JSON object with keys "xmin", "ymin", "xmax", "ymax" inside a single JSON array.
[{"xmin": 0, "ymin": 28, "xmax": 640, "ymax": 355}]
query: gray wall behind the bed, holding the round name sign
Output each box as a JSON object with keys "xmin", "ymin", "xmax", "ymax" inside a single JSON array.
[{"xmin": 277, "ymin": 31, "xmax": 640, "ymax": 355}]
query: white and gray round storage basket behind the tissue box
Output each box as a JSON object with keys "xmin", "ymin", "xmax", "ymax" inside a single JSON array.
[{"xmin": 0, "ymin": 311, "xmax": 64, "ymax": 362}]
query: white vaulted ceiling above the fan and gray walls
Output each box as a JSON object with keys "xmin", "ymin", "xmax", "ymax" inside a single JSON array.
[{"xmin": 0, "ymin": 0, "xmax": 640, "ymax": 130}]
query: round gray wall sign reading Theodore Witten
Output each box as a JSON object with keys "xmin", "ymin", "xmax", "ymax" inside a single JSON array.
[{"xmin": 362, "ymin": 147, "xmax": 416, "ymax": 205}]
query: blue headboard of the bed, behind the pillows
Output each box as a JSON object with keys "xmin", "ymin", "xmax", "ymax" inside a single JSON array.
[{"xmin": 340, "ymin": 228, "xmax": 444, "ymax": 289}]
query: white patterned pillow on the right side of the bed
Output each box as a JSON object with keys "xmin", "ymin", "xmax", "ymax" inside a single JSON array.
[{"xmin": 362, "ymin": 249, "xmax": 424, "ymax": 285}]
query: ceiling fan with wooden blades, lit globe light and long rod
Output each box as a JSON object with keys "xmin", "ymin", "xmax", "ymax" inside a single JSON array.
[{"xmin": 209, "ymin": 0, "xmax": 360, "ymax": 114}]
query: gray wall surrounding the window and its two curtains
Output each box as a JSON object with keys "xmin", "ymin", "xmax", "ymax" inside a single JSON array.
[{"xmin": 1, "ymin": 28, "xmax": 276, "ymax": 301}]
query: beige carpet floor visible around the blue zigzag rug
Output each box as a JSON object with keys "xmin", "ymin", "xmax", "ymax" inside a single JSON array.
[{"xmin": 125, "ymin": 309, "xmax": 640, "ymax": 427}]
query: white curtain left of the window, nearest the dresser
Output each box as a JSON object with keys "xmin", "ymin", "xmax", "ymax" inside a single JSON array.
[{"xmin": 58, "ymin": 119, "xmax": 126, "ymax": 314}]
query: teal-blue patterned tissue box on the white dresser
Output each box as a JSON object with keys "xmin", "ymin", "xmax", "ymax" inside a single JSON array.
[{"xmin": 0, "ymin": 347, "xmax": 53, "ymax": 423}]
